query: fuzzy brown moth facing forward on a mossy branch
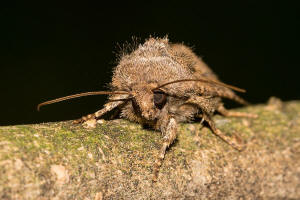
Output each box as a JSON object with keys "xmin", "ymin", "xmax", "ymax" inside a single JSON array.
[{"xmin": 38, "ymin": 37, "xmax": 256, "ymax": 181}]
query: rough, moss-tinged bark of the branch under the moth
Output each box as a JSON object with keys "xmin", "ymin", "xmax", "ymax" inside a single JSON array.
[{"xmin": 0, "ymin": 98, "xmax": 300, "ymax": 199}]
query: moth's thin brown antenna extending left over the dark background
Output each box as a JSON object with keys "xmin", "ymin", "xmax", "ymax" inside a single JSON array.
[{"xmin": 37, "ymin": 91, "xmax": 129, "ymax": 111}]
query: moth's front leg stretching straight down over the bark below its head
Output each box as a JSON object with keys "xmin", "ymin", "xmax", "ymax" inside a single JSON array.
[{"xmin": 152, "ymin": 118, "xmax": 177, "ymax": 181}]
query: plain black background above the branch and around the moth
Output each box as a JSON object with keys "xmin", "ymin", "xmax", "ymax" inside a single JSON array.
[{"xmin": 0, "ymin": 1, "xmax": 300, "ymax": 125}]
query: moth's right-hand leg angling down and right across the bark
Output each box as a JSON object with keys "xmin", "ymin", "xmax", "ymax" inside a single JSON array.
[{"xmin": 203, "ymin": 114, "xmax": 245, "ymax": 151}]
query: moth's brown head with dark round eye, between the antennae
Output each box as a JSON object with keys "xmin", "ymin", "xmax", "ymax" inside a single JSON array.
[{"xmin": 131, "ymin": 83, "xmax": 167, "ymax": 121}]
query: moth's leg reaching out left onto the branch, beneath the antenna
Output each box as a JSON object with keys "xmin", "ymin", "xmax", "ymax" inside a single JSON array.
[{"xmin": 73, "ymin": 101, "xmax": 124, "ymax": 124}]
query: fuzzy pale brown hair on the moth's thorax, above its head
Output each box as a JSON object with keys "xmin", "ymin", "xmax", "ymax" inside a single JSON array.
[{"xmin": 112, "ymin": 38, "xmax": 192, "ymax": 92}]
